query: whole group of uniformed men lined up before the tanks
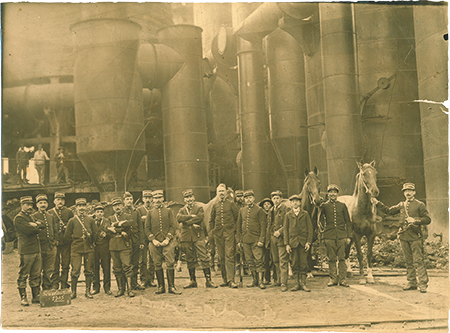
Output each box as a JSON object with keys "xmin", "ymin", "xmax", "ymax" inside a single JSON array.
[{"xmin": 14, "ymin": 180, "xmax": 430, "ymax": 305}]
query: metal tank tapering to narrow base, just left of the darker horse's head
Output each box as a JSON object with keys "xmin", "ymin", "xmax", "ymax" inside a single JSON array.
[{"xmin": 265, "ymin": 29, "xmax": 309, "ymax": 196}]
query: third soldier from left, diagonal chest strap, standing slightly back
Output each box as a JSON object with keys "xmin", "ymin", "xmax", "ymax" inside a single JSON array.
[{"xmin": 48, "ymin": 192, "xmax": 73, "ymax": 289}]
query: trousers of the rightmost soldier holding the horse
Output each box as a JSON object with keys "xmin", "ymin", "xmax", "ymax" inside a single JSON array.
[{"xmin": 400, "ymin": 239, "xmax": 428, "ymax": 287}]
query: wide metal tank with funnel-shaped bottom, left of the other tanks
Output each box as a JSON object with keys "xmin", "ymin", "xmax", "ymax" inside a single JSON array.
[{"xmin": 72, "ymin": 19, "xmax": 145, "ymax": 192}]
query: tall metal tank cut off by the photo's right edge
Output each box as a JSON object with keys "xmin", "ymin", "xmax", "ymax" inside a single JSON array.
[{"xmin": 414, "ymin": 4, "xmax": 449, "ymax": 241}]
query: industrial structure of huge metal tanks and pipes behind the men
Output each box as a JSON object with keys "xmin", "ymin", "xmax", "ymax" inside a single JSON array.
[{"xmin": 2, "ymin": 3, "xmax": 449, "ymax": 239}]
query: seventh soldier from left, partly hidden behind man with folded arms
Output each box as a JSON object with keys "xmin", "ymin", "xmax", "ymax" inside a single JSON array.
[{"xmin": 123, "ymin": 192, "xmax": 145, "ymax": 290}]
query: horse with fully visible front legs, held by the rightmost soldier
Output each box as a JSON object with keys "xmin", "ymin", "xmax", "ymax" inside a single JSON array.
[{"xmin": 338, "ymin": 161, "xmax": 380, "ymax": 284}]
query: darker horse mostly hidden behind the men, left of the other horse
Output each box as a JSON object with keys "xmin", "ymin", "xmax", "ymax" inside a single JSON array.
[{"xmin": 300, "ymin": 167, "xmax": 320, "ymax": 277}]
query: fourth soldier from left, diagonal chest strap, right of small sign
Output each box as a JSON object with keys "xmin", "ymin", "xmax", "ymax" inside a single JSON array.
[{"xmin": 64, "ymin": 198, "xmax": 98, "ymax": 299}]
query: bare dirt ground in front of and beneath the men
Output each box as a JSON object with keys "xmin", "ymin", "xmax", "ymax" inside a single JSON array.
[{"xmin": 1, "ymin": 251, "xmax": 449, "ymax": 332}]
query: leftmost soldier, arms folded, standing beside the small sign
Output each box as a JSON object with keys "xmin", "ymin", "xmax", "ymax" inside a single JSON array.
[{"xmin": 14, "ymin": 196, "xmax": 45, "ymax": 306}]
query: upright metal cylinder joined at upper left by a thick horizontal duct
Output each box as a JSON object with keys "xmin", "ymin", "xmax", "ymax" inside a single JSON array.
[{"xmin": 158, "ymin": 25, "xmax": 210, "ymax": 202}]
